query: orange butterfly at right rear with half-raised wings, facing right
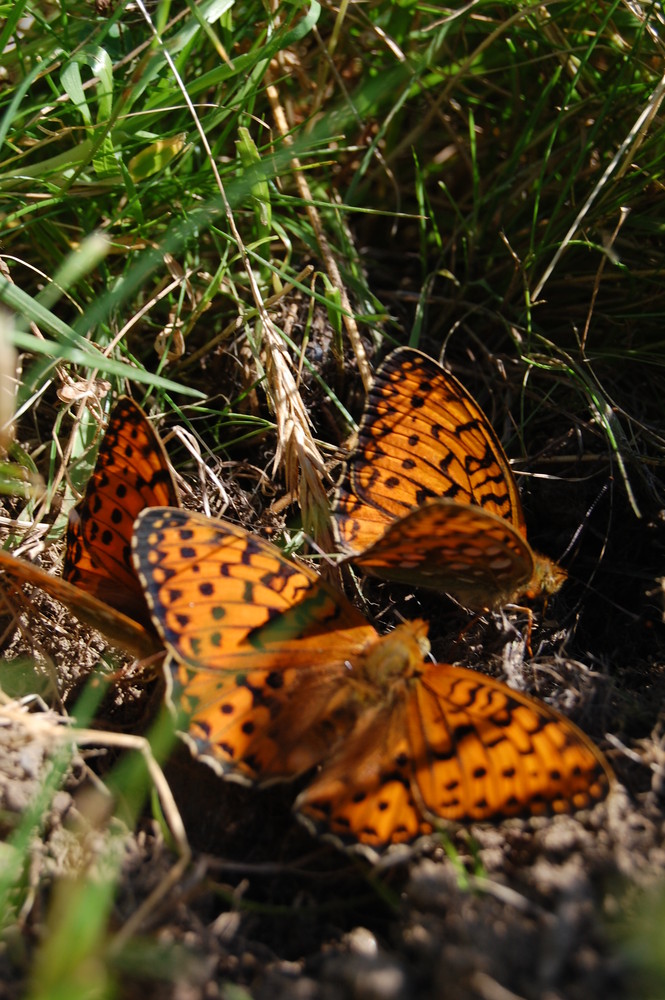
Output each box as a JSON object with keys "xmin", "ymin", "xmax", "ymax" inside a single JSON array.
[{"xmin": 332, "ymin": 347, "xmax": 566, "ymax": 610}]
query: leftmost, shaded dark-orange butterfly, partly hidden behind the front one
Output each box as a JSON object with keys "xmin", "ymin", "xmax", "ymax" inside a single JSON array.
[{"xmin": 0, "ymin": 396, "xmax": 179, "ymax": 658}]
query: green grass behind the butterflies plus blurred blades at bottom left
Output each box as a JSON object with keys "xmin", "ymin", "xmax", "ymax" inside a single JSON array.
[{"xmin": 0, "ymin": 0, "xmax": 665, "ymax": 1000}]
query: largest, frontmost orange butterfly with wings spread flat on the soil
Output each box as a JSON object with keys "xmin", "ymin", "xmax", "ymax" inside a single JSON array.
[{"xmin": 132, "ymin": 508, "xmax": 611, "ymax": 858}]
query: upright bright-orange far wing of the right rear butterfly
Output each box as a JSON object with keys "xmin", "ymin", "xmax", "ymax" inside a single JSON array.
[{"xmin": 333, "ymin": 348, "xmax": 525, "ymax": 552}]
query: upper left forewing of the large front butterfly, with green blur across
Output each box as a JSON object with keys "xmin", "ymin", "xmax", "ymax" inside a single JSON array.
[{"xmin": 133, "ymin": 508, "xmax": 376, "ymax": 670}]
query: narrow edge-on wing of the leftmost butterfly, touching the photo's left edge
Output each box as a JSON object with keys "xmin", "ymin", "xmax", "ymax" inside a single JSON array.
[{"xmin": 0, "ymin": 550, "xmax": 156, "ymax": 659}]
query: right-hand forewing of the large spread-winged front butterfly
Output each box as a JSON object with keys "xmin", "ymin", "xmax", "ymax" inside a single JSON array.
[{"xmin": 416, "ymin": 664, "xmax": 612, "ymax": 820}]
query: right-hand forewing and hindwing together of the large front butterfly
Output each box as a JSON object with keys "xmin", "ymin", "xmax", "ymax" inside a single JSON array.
[{"xmin": 296, "ymin": 663, "xmax": 612, "ymax": 854}]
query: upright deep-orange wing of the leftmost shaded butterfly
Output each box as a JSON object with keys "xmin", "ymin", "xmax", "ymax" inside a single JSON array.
[{"xmin": 63, "ymin": 396, "xmax": 179, "ymax": 623}]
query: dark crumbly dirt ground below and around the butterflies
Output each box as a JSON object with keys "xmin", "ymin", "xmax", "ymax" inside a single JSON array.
[{"xmin": 0, "ymin": 338, "xmax": 665, "ymax": 1000}]
